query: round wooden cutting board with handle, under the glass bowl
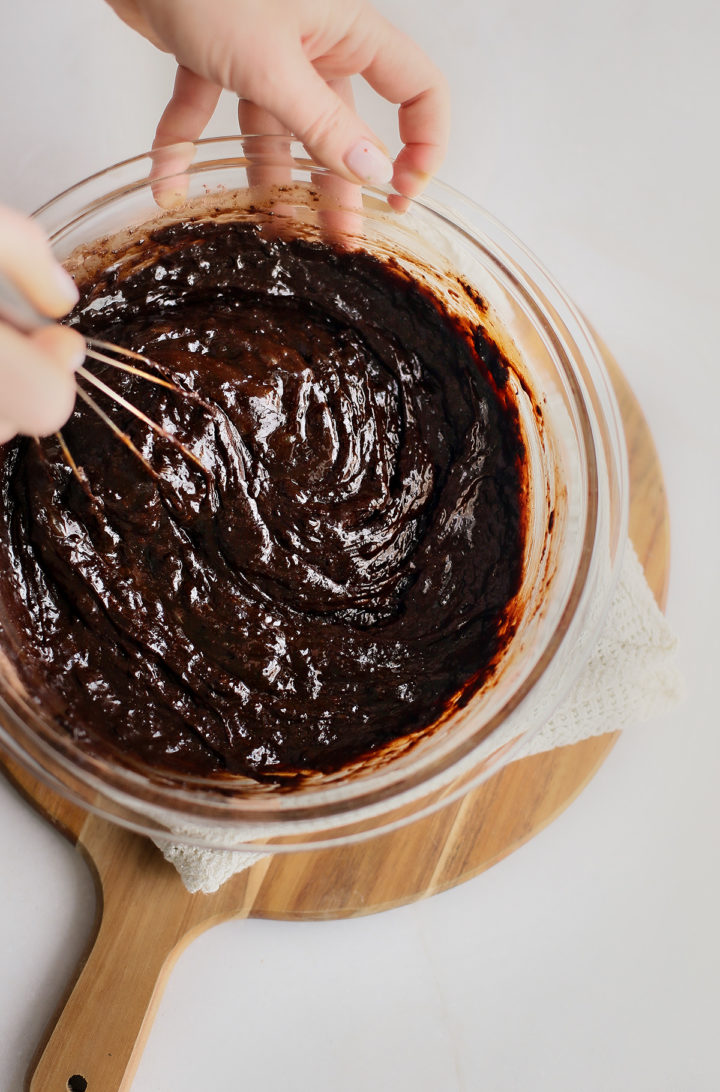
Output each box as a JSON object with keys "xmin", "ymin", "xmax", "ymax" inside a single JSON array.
[{"xmin": 4, "ymin": 345, "xmax": 670, "ymax": 1092}]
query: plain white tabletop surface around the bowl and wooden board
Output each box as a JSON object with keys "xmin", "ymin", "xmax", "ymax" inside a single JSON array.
[{"xmin": 0, "ymin": 0, "xmax": 720, "ymax": 1092}]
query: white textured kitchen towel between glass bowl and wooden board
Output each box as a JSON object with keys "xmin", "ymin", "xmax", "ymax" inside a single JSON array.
[{"xmin": 157, "ymin": 543, "xmax": 682, "ymax": 894}]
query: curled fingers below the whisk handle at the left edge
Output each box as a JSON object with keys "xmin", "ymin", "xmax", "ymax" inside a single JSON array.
[{"xmin": 0, "ymin": 323, "xmax": 85, "ymax": 442}]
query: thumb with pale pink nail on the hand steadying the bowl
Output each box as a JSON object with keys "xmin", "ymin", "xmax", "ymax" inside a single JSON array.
[{"xmin": 244, "ymin": 49, "xmax": 393, "ymax": 186}]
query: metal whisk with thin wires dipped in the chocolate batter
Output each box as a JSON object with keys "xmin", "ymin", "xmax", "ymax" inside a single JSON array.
[{"xmin": 0, "ymin": 272, "xmax": 205, "ymax": 482}]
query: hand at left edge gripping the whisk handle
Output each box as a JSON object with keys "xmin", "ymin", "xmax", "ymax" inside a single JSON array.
[{"xmin": 0, "ymin": 207, "xmax": 85, "ymax": 443}]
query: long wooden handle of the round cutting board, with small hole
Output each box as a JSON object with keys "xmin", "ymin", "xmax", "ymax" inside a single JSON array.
[{"xmin": 26, "ymin": 817, "xmax": 230, "ymax": 1092}]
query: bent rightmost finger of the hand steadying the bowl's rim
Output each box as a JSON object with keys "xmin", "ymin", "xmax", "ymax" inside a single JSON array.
[{"xmin": 363, "ymin": 16, "xmax": 450, "ymax": 198}]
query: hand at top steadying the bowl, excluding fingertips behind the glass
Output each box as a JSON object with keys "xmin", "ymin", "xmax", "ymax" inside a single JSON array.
[{"xmin": 108, "ymin": 0, "xmax": 449, "ymax": 197}]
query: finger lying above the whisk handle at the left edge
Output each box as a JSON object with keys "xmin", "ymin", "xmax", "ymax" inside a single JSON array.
[{"xmin": 0, "ymin": 209, "xmax": 78, "ymax": 319}]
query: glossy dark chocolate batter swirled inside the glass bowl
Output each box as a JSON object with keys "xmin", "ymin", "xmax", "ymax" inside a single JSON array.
[{"xmin": 0, "ymin": 222, "xmax": 524, "ymax": 781}]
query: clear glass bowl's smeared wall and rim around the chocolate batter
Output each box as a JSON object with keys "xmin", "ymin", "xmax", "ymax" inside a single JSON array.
[{"xmin": 0, "ymin": 137, "xmax": 628, "ymax": 852}]
